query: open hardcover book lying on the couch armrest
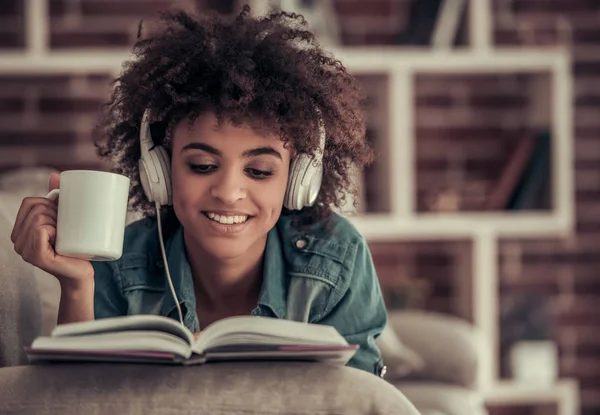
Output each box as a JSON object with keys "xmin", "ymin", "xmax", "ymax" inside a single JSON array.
[{"xmin": 26, "ymin": 315, "xmax": 358, "ymax": 365}]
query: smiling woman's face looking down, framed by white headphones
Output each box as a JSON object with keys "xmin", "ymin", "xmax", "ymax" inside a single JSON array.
[{"xmin": 171, "ymin": 112, "xmax": 290, "ymax": 259}]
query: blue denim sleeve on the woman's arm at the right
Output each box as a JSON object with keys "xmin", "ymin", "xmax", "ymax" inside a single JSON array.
[{"xmin": 320, "ymin": 239, "xmax": 387, "ymax": 376}]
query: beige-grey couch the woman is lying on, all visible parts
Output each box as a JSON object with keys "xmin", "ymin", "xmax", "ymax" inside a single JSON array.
[{"xmin": 0, "ymin": 171, "xmax": 485, "ymax": 415}]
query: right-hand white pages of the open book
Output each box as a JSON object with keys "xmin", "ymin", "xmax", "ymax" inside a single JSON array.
[{"xmin": 192, "ymin": 316, "xmax": 348, "ymax": 353}]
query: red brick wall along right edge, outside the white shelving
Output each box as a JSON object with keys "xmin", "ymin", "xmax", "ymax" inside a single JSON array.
[{"xmin": 494, "ymin": 0, "xmax": 600, "ymax": 414}]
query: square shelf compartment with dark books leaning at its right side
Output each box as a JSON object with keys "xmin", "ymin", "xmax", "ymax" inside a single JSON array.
[{"xmin": 415, "ymin": 72, "xmax": 553, "ymax": 213}]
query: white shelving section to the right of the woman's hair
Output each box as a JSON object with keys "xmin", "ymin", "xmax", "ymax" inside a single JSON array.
[{"xmin": 337, "ymin": 5, "xmax": 574, "ymax": 406}]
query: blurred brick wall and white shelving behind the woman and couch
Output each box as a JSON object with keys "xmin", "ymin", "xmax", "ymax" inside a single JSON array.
[{"xmin": 0, "ymin": 0, "xmax": 600, "ymax": 415}]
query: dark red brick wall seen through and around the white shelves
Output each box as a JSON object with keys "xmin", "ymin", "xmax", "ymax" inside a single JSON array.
[{"xmin": 0, "ymin": 0, "xmax": 600, "ymax": 415}]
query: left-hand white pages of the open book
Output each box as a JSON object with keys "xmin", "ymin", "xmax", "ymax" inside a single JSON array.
[{"xmin": 51, "ymin": 314, "xmax": 194, "ymax": 345}]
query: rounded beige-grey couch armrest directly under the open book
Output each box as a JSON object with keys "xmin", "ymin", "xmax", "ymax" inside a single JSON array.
[{"xmin": 0, "ymin": 362, "xmax": 419, "ymax": 415}]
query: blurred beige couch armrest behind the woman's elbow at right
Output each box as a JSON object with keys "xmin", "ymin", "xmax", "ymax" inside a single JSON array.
[{"xmin": 389, "ymin": 311, "xmax": 485, "ymax": 387}]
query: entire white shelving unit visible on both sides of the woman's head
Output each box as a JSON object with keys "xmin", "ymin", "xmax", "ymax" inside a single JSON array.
[{"xmin": 0, "ymin": 0, "xmax": 577, "ymax": 415}]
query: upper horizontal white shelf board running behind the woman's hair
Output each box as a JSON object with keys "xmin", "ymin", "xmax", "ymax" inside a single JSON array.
[{"xmin": 0, "ymin": 46, "xmax": 569, "ymax": 75}]
